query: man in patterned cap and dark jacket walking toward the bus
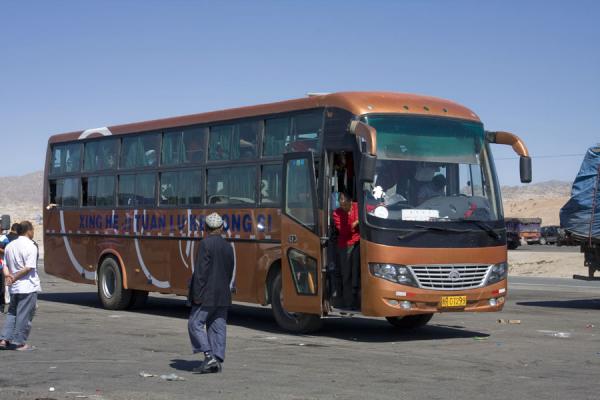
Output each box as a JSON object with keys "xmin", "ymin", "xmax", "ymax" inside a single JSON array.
[{"xmin": 188, "ymin": 213, "xmax": 235, "ymax": 374}]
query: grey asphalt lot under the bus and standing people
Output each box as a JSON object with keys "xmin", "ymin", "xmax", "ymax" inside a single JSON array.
[{"xmin": 0, "ymin": 268, "xmax": 600, "ymax": 400}]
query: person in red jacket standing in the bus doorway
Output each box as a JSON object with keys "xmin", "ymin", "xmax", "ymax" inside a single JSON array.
[{"xmin": 333, "ymin": 192, "xmax": 360, "ymax": 309}]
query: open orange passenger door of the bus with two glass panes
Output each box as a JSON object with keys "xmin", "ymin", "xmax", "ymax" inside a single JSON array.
[{"xmin": 281, "ymin": 152, "xmax": 324, "ymax": 315}]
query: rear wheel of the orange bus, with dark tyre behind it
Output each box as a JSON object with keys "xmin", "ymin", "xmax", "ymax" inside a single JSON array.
[{"xmin": 98, "ymin": 257, "xmax": 132, "ymax": 310}]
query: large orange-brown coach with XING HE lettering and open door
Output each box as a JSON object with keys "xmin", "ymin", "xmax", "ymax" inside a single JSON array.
[{"xmin": 44, "ymin": 92, "xmax": 531, "ymax": 332}]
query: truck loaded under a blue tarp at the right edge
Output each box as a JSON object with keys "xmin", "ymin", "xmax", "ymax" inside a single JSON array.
[{"xmin": 560, "ymin": 144, "xmax": 600, "ymax": 280}]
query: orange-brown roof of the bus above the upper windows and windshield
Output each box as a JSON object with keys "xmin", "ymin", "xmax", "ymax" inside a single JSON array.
[{"xmin": 49, "ymin": 92, "xmax": 479, "ymax": 143}]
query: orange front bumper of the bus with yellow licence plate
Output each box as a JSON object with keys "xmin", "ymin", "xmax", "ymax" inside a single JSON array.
[{"xmin": 362, "ymin": 279, "xmax": 508, "ymax": 317}]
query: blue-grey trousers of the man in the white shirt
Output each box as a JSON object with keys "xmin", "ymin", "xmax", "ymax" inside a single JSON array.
[{"xmin": 0, "ymin": 292, "xmax": 37, "ymax": 345}]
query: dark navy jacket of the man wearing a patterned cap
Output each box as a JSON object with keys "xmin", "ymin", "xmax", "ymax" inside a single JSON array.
[{"xmin": 188, "ymin": 235, "xmax": 234, "ymax": 307}]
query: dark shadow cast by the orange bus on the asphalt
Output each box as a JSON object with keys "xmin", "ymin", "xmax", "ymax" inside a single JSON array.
[{"xmin": 38, "ymin": 292, "xmax": 489, "ymax": 343}]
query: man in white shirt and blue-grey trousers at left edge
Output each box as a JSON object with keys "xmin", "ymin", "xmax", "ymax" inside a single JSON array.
[{"xmin": 0, "ymin": 221, "xmax": 42, "ymax": 351}]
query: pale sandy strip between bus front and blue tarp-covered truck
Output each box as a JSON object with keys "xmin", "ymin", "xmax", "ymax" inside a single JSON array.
[{"xmin": 508, "ymin": 247, "xmax": 587, "ymax": 278}]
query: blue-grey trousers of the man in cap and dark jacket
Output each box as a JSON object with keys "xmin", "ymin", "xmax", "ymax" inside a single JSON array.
[{"xmin": 188, "ymin": 305, "xmax": 229, "ymax": 361}]
